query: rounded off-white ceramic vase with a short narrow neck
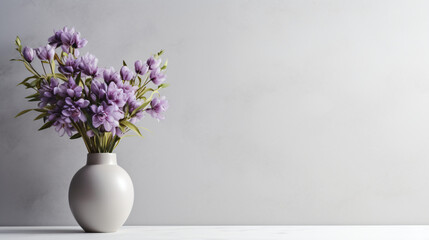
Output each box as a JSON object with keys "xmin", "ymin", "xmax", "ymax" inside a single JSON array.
[{"xmin": 69, "ymin": 153, "xmax": 134, "ymax": 232}]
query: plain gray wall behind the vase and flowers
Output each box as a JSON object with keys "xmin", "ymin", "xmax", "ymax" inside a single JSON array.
[{"xmin": 0, "ymin": 0, "xmax": 429, "ymax": 225}]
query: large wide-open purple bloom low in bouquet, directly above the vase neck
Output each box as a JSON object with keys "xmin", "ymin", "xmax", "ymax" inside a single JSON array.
[{"xmin": 90, "ymin": 102, "xmax": 124, "ymax": 132}]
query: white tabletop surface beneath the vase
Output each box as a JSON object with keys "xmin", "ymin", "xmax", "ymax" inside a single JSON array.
[{"xmin": 0, "ymin": 225, "xmax": 429, "ymax": 240}]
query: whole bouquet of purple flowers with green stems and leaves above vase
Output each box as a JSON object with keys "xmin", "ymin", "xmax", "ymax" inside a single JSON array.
[{"xmin": 11, "ymin": 27, "xmax": 168, "ymax": 153}]
